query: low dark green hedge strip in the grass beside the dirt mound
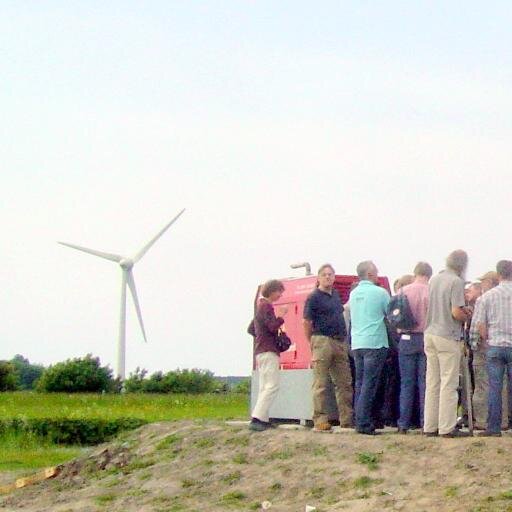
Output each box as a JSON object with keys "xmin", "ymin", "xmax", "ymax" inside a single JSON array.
[{"xmin": 0, "ymin": 418, "xmax": 147, "ymax": 445}]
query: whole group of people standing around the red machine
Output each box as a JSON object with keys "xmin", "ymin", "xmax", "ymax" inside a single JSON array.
[{"xmin": 249, "ymin": 250, "xmax": 512, "ymax": 438}]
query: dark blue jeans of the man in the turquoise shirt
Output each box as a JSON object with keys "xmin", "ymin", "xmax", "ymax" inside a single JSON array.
[{"xmin": 353, "ymin": 348, "xmax": 388, "ymax": 432}]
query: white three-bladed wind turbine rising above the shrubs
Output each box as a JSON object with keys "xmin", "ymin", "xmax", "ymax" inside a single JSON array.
[{"xmin": 58, "ymin": 208, "xmax": 185, "ymax": 380}]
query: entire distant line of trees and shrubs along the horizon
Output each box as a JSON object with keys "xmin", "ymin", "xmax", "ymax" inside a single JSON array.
[{"xmin": 0, "ymin": 354, "xmax": 250, "ymax": 393}]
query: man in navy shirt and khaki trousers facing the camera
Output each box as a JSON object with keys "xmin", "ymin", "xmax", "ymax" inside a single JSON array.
[{"xmin": 304, "ymin": 264, "xmax": 352, "ymax": 431}]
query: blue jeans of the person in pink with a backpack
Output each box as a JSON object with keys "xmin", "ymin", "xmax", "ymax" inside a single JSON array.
[{"xmin": 398, "ymin": 352, "xmax": 427, "ymax": 430}]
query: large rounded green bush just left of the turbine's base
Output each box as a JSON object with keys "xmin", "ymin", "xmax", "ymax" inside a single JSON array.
[{"xmin": 37, "ymin": 354, "xmax": 116, "ymax": 393}]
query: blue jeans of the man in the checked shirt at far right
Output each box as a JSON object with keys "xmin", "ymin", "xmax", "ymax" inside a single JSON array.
[{"xmin": 487, "ymin": 347, "xmax": 512, "ymax": 433}]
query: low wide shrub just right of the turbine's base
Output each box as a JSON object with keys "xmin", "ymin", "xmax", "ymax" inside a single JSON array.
[{"xmin": 124, "ymin": 368, "xmax": 219, "ymax": 394}]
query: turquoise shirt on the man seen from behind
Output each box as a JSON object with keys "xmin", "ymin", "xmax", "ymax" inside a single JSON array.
[{"xmin": 350, "ymin": 280, "xmax": 389, "ymax": 350}]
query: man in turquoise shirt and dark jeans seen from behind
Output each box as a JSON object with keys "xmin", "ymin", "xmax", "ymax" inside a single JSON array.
[{"xmin": 350, "ymin": 261, "xmax": 389, "ymax": 435}]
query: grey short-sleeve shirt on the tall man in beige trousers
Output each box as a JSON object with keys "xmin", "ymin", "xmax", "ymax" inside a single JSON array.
[{"xmin": 425, "ymin": 269, "xmax": 466, "ymax": 341}]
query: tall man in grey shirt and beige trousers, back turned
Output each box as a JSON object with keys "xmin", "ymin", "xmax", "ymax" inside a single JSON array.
[{"xmin": 424, "ymin": 250, "xmax": 471, "ymax": 437}]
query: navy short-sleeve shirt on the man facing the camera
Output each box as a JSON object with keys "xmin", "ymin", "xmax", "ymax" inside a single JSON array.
[{"xmin": 304, "ymin": 288, "xmax": 346, "ymax": 338}]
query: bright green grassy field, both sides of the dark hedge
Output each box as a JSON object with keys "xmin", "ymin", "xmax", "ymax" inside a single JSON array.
[{"xmin": 0, "ymin": 392, "xmax": 249, "ymax": 472}]
